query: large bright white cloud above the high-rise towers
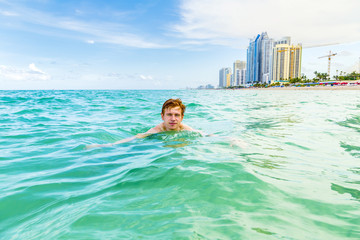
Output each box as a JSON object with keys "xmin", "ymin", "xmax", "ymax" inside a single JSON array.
[{"xmin": 172, "ymin": 0, "xmax": 360, "ymax": 44}]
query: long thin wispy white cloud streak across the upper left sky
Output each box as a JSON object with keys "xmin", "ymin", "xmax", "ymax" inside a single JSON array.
[{"xmin": 0, "ymin": 5, "xmax": 169, "ymax": 48}]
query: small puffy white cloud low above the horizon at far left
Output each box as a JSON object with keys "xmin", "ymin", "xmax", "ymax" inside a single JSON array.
[{"xmin": 0, "ymin": 63, "xmax": 50, "ymax": 81}]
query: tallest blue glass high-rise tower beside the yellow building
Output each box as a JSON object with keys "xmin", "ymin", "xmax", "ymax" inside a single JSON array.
[{"xmin": 246, "ymin": 32, "xmax": 274, "ymax": 85}]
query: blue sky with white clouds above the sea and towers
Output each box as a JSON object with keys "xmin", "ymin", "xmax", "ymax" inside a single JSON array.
[{"xmin": 0, "ymin": 0, "xmax": 360, "ymax": 90}]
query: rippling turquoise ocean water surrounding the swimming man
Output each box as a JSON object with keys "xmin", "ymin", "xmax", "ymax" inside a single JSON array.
[{"xmin": 0, "ymin": 90, "xmax": 360, "ymax": 239}]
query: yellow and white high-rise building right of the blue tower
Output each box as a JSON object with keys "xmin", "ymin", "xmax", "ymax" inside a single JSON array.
[{"xmin": 272, "ymin": 44, "xmax": 302, "ymax": 83}]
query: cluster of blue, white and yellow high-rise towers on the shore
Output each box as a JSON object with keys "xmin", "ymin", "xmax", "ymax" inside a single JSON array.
[{"xmin": 218, "ymin": 32, "xmax": 302, "ymax": 88}]
